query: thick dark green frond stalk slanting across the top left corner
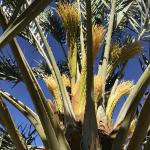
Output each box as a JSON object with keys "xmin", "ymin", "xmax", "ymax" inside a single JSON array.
[{"xmin": 1, "ymin": 0, "xmax": 51, "ymax": 46}]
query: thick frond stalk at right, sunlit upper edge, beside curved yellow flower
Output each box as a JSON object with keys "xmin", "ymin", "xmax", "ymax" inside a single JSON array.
[{"xmin": 112, "ymin": 65, "xmax": 150, "ymax": 150}]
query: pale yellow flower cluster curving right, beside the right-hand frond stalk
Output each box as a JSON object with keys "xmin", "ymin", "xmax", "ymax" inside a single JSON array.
[{"xmin": 106, "ymin": 81, "xmax": 133, "ymax": 121}]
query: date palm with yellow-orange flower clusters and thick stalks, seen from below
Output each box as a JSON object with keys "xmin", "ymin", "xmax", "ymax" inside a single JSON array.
[{"xmin": 0, "ymin": 0, "xmax": 150, "ymax": 150}]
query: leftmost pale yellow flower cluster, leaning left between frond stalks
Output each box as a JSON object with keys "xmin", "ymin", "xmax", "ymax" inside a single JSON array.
[{"xmin": 44, "ymin": 75, "xmax": 63, "ymax": 113}]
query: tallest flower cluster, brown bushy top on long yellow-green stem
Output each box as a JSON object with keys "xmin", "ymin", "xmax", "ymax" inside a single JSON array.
[{"xmin": 58, "ymin": 3, "xmax": 80, "ymax": 92}]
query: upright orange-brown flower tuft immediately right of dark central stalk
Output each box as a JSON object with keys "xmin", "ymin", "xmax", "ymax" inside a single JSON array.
[{"xmin": 92, "ymin": 25, "xmax": 105, "ymax": 59}]
